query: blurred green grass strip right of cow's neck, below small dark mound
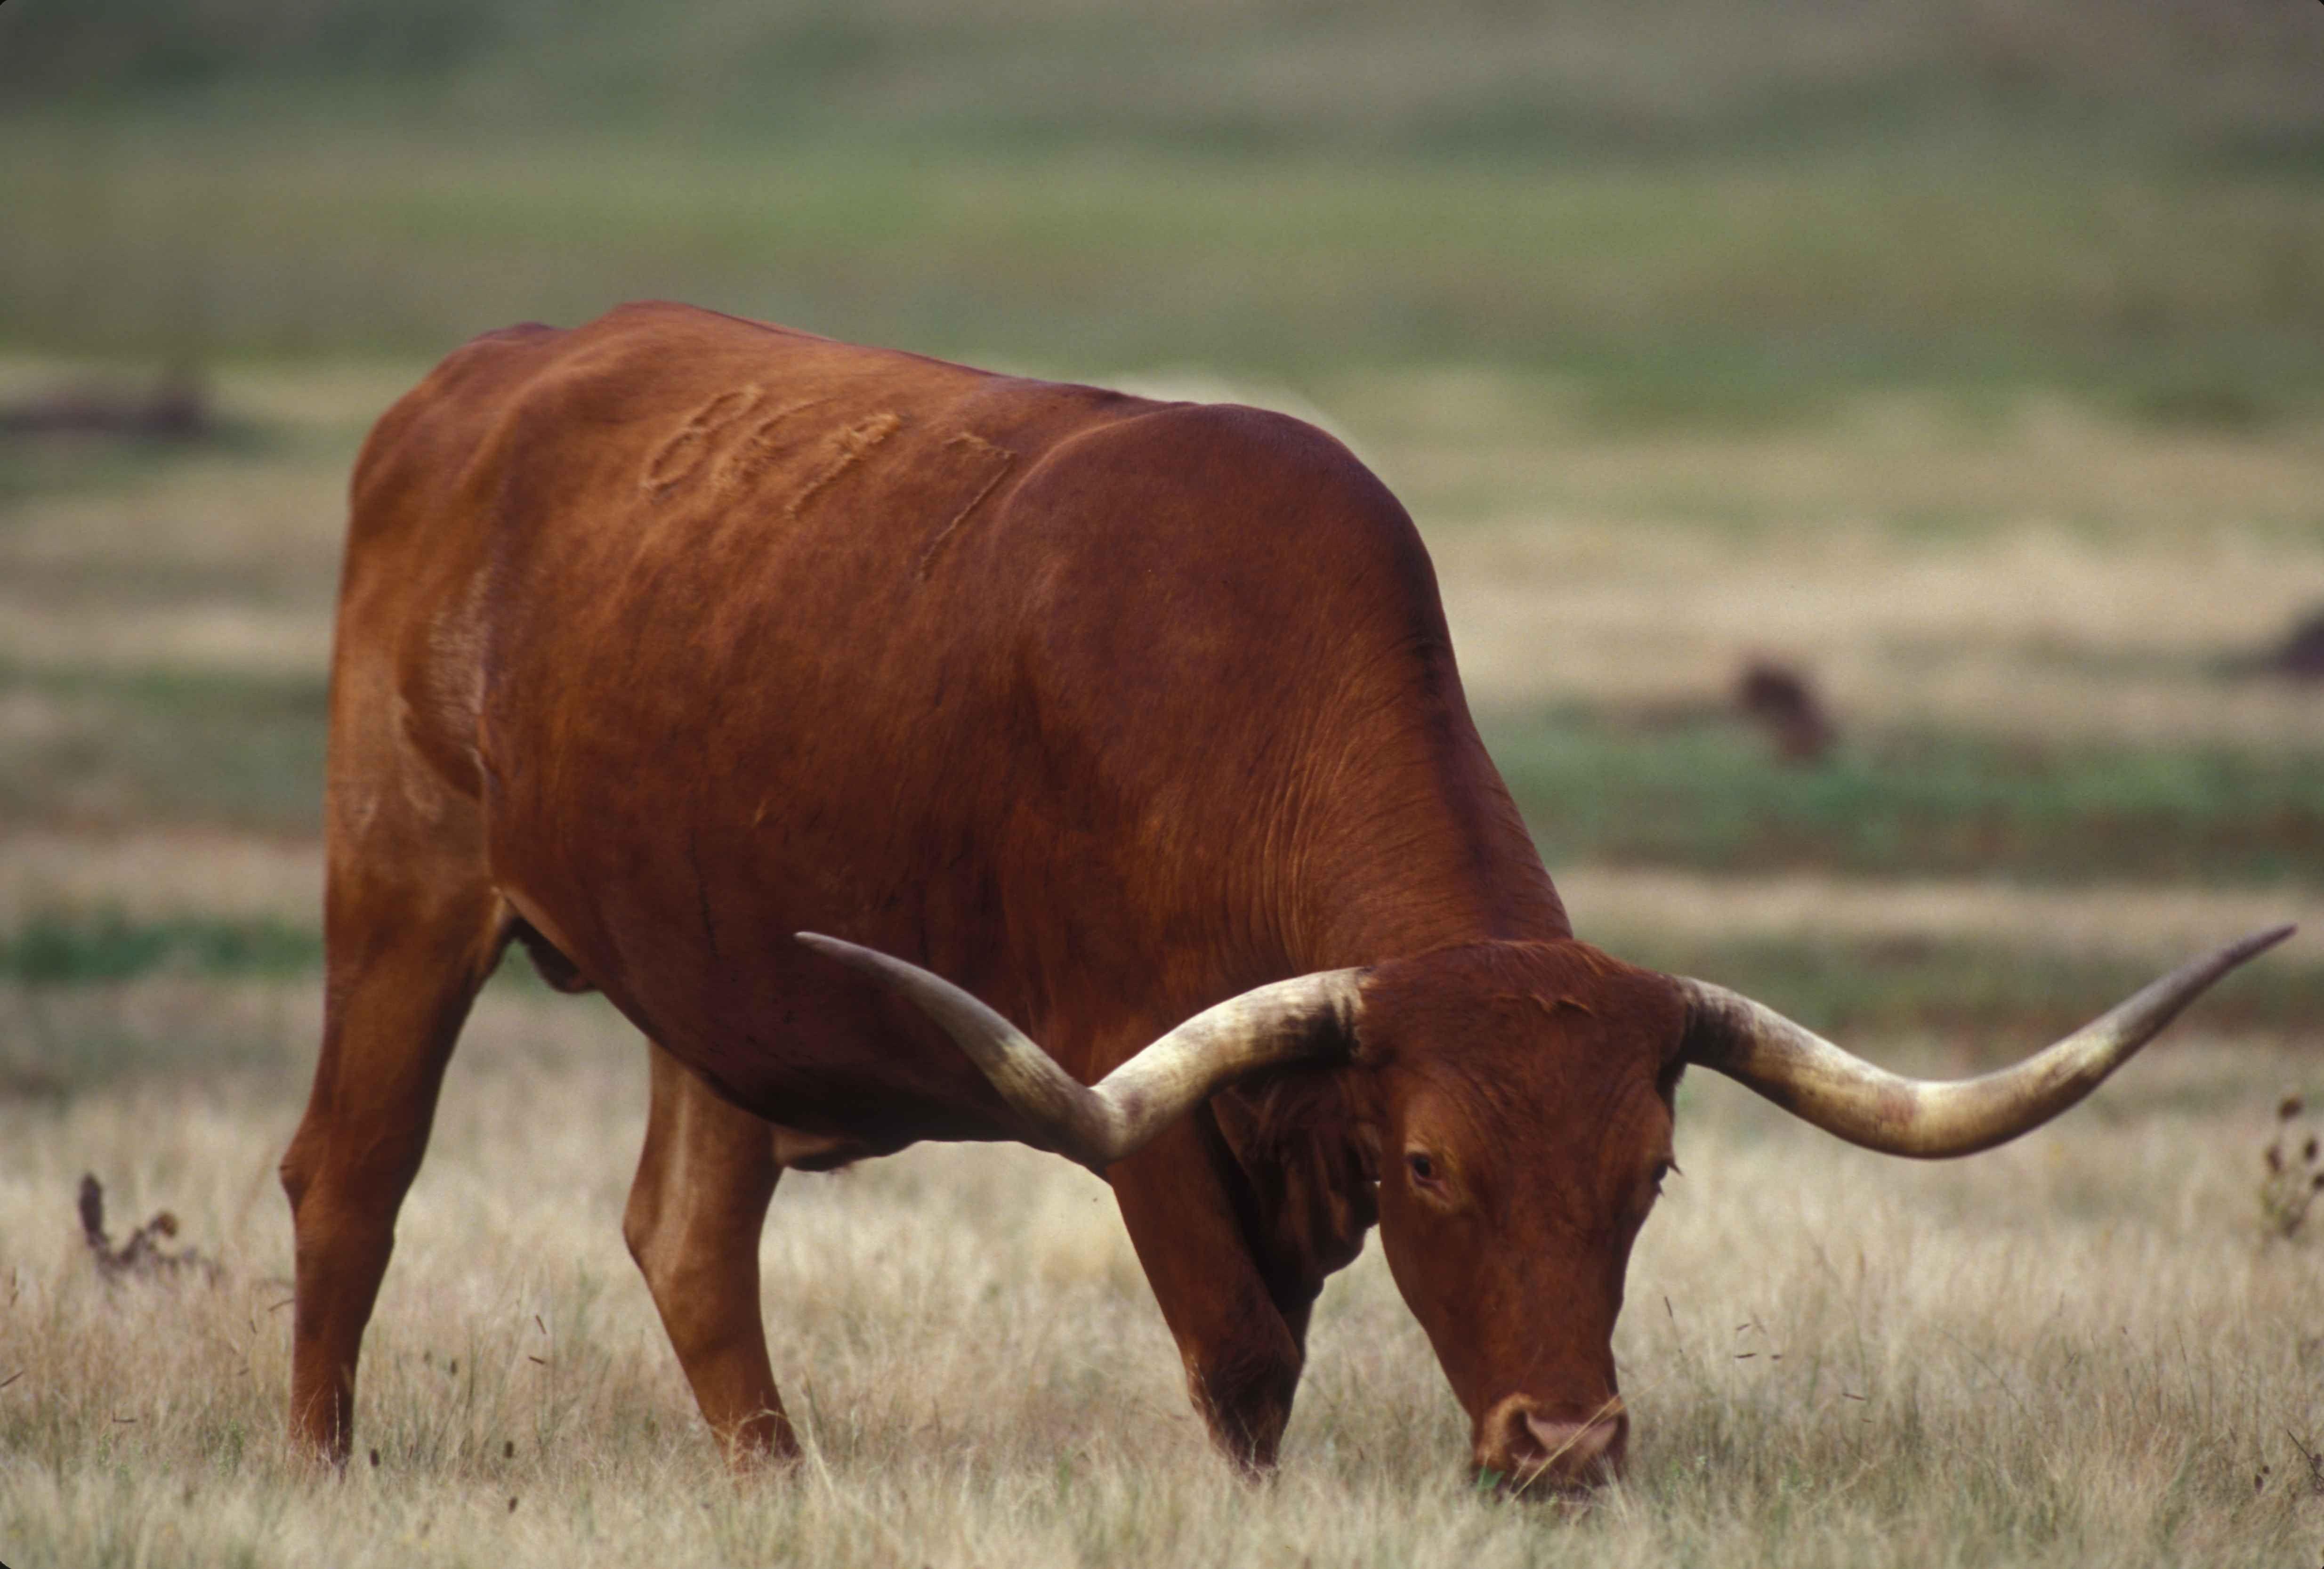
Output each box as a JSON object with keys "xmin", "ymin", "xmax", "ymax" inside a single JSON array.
[{"xmin": 1485, "ymin": 707, "xmax": 2324, "ymax": 883}]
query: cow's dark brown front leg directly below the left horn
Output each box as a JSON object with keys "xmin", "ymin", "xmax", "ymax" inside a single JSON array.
[{"xmin": 1106, "ymin": 1111, "xmax": 1306, "ymax": 1472}]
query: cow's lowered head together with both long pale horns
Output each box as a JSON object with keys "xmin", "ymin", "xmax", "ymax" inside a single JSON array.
[{"xmin": 802, "ymin": 928, "xmax": 2292, "ymax": 1490}]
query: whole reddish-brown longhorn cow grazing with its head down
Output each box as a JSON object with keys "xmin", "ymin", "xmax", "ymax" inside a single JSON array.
[{"xmin": 283, "ymin": 305, "xmax": 2280, "ymax": 1485}]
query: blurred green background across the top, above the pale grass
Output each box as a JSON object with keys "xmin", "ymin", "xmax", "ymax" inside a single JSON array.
[{"xmin": 13, "ymin": 0, "xmax": 2324, "ymax": 425}]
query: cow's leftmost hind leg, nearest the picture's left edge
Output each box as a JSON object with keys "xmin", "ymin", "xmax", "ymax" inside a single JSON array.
[{"xmin": 281, "ymin": 827, "xmax": 509, "ymax": 1462}]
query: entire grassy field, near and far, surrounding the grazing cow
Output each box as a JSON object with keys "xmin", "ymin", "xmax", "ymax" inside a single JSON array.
[{"xmin": 0, "ymin": 0, "xmax": 2324, "ymax": 1567}]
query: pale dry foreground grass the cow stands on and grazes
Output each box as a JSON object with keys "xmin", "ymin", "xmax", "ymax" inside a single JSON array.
[{"xmin": 0, "ymin": 988, "xmax": 2324, "ymax": 1564}]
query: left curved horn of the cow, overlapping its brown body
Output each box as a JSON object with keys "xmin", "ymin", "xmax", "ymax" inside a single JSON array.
[{"xmin": 797, "ymin": 932, "xmax": 1366, "ymax": 1174}]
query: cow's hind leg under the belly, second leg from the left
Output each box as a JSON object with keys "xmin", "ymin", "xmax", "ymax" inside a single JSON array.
[{"xmin": 623, "ymin": 1046, "xmax": 799, "ymax": 1472}]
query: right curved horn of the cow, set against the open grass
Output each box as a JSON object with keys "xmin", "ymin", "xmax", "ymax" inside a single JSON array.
[{"xmin": 1676, "ymin": 925, "xmax": 2299, "ymax": 1160}]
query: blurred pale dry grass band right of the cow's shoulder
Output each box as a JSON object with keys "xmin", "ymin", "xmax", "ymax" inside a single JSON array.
[{"xmin": 1331, "ymin": 372, "xmax": 2324, "ymax": 746}]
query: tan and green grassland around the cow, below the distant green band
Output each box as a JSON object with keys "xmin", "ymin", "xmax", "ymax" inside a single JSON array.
[{"xmin": 0, "ymin": 346, "xmax": 2324, "ymax": 1564}]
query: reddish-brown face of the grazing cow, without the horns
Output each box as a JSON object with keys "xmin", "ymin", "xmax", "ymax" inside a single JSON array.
[{"xmin": 1348, "ymin": 941, "xmax": 1685, "ymax": 1483}]
